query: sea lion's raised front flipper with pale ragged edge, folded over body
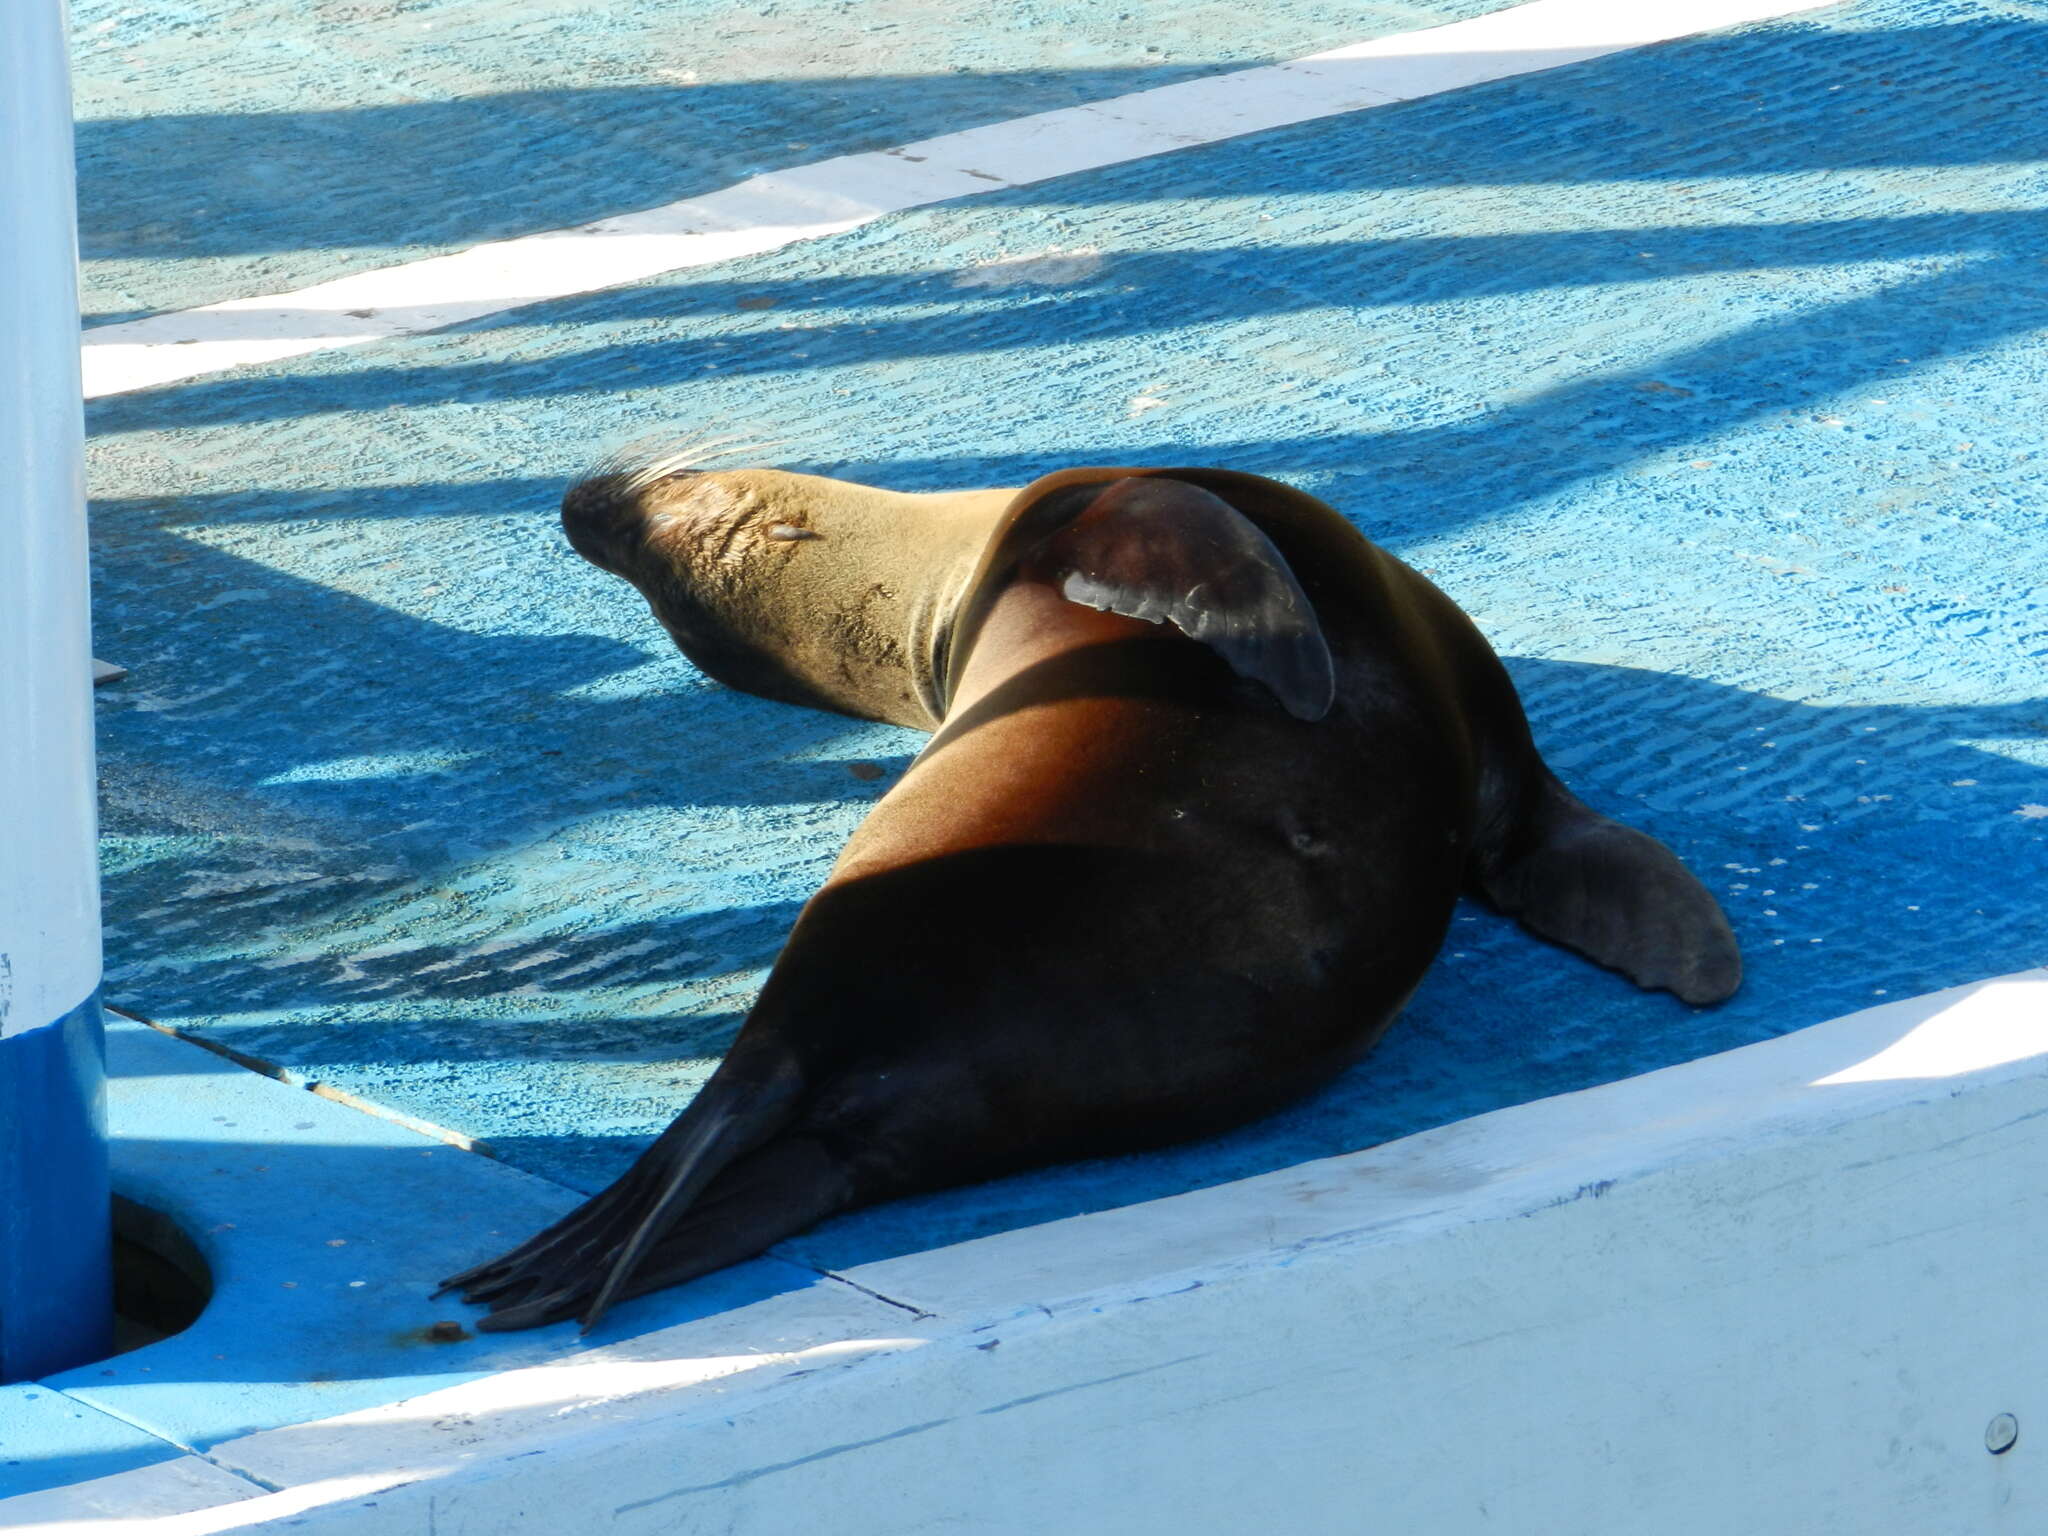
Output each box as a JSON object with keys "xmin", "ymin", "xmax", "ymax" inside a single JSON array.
[{"xmin": 1032, "ymin": 477, "xmax": 1337, "ymax": 721}]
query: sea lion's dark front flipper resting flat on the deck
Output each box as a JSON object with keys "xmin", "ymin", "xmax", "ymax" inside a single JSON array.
[{"xmin": 1477, "ymin": 774, "xmax": 1743, "ymax": 1004}]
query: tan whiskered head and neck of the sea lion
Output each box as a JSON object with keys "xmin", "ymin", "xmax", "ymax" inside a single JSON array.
[{"xmin": 561, "ymin": 453, "xmax": 1016, "ymax": 729}]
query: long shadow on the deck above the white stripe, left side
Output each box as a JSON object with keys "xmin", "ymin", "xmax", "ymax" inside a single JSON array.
[{"xmin": 78, "ymin": 63, "xmax": 1196, "ymax": 274}]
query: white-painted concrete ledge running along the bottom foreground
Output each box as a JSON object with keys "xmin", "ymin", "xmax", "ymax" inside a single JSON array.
[{"xmin": 0, "ymin": 971, "xmax": 2048, "ymax": 1536}]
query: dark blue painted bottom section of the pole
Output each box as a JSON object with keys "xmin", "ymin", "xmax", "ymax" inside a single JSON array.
[{"xmin": 0, "ymin": 991, "xmax": 113, "ymax": 1382}]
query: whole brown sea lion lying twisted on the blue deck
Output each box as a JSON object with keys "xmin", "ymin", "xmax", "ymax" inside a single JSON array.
[{"xmin": 446, "ymin": 461, "xmax": 1741, "ymax": 1329}]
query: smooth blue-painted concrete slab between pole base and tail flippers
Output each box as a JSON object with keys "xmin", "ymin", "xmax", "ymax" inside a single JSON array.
[{"xmin": 33, "ymin": 1022, "xmax": 825, "ymax": 1456}]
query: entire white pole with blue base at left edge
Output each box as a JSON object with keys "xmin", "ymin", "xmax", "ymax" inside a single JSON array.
[{"xmin": 0, "ymin": 0, "xmax": 113, "ymax": 1380}]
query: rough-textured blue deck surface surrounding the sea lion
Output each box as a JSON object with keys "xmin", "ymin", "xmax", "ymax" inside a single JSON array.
[{"xmin": 16, "ymin": 0, "xmax": 2048, "ymax": 1507}]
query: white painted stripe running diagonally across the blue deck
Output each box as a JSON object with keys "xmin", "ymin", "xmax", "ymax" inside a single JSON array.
[{"xmin": 84, "ymin": 0, "xmax": 1833, "ymax": 399}]
